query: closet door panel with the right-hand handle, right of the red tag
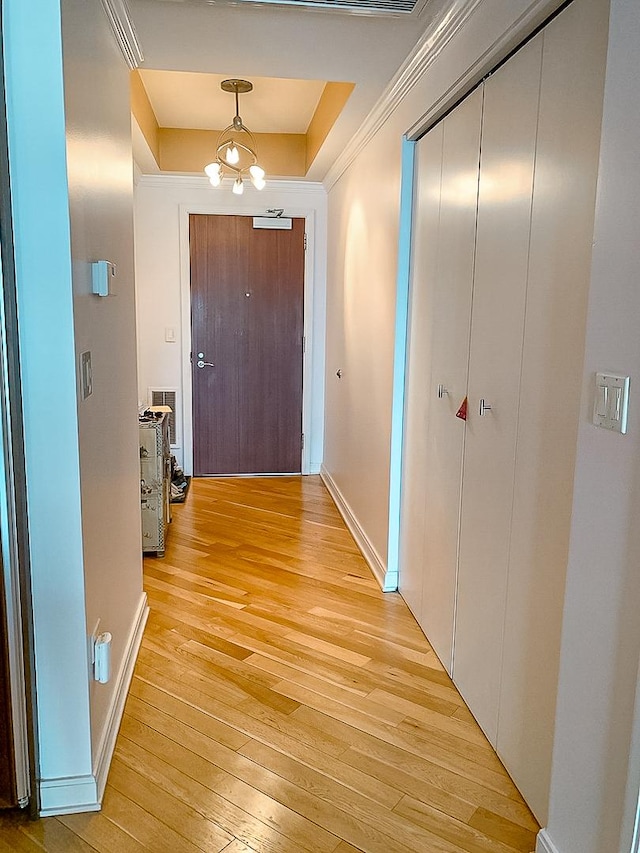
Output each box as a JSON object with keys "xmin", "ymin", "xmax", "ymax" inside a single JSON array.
[{"xmin": 453, "ymin": 37, "xmax": 542, "ymax": 744}]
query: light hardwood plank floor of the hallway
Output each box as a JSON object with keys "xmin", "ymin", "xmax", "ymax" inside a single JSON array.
[{"xmin": 0, "ymin": 477, "xmax": 538, "ymax": 853}]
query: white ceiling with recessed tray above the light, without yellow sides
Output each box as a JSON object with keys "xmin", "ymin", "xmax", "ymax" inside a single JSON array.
[{"xmin": 128, "ymin": 0, "xmax": 451, "ymax": 180}]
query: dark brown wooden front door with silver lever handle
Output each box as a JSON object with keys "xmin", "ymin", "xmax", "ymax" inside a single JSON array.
[{"xmin": 189, "ymin": 214, "xmax": 304, "ymax": 476}]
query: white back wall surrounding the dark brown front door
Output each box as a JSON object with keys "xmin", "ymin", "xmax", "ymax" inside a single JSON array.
[{"xmin": 135, "ymin": 175, "xmax": 327, "ymax": 473}]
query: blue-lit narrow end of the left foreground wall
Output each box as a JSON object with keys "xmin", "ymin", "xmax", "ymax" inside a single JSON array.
[{"xmin": 3, "ymin": 0, "xmax": 97, "ymax": 808}]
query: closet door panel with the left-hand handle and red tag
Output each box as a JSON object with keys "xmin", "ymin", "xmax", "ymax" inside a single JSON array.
[{"xmin": 420, "ymin": 88, "xmax": 482, "ymax": 673}]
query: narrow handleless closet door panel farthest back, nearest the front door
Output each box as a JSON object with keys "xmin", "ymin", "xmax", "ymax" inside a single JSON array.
[{"xmin": 399, "ymin": 124, "xmax": 443, "ymax": 622}]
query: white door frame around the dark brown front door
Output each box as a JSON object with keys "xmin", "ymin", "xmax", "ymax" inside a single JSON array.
[{"xmin": 180, "ymin": 204, "xmax": 316, "ymax": 474}]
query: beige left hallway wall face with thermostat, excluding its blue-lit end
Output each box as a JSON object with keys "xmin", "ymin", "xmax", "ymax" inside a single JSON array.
[{"xmin": 62, "ymin": 0, "xmax": 145, "ymax": 792}]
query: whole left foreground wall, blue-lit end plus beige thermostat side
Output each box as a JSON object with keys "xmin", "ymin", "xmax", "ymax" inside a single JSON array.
[{"xmin": 4, "ymin": 0, "xmax": 144, "ymax": 813}]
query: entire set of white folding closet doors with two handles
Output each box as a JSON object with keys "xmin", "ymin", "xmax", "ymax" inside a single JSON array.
[{"xmin": 400, "ymin": 0, "xmax": 608, "ymax": 823}]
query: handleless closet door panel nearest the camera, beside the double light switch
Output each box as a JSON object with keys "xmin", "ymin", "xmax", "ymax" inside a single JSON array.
[{"xmin": 498, "ymin": 0, "xmax": 608, "ymax": 825}]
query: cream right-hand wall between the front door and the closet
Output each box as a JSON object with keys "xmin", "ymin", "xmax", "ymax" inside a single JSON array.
[{"xmin": 323, "ymin": 118, "xmax": 401, "ymax": 566}]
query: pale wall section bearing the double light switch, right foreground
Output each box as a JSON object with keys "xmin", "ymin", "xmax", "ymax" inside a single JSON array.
[{"xmin": 539, "ymin": 0, "xmax": 640, "ymax": 853}]
